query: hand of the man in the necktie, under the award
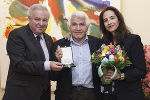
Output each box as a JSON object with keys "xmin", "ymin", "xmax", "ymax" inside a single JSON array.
[{"xmin": 50, "ymin": 61, "xmax": 62, "ymax": 71}]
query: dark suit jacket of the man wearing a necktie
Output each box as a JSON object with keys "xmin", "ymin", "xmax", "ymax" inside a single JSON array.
[{"xmin": 3, "ymin": 25, "xmax": 53, "ymax": 100}]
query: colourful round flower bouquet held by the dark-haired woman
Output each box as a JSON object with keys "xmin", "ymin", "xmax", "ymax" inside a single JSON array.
[{"xmin": 91, "ymin": 44, "xmax": 132, "ymax": 84}]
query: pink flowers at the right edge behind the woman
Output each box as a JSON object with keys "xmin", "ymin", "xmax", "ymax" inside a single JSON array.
[{"xmin": 142, "ymin": 45, "xmax": 150, "ymax": 100}]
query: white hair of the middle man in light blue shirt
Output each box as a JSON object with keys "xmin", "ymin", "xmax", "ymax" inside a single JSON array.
[{"xmin": 68, "ymin": 11, "xmax": 90, "ymax": 27}]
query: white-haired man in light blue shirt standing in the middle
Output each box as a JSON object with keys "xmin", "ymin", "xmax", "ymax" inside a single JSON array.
[{"xmin": 53, "ymin": 11, "xmax": 102, "ymax": 100}]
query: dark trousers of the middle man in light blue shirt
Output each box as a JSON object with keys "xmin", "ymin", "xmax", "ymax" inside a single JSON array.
[{"xmin": 72, "ymin": 87, "xmax": 97, "ymax": 100}]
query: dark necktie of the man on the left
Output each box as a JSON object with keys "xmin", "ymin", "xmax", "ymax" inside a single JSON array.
[{"xmin": 36, "ymin": 35, "xmax": 50, "ymax": 90}]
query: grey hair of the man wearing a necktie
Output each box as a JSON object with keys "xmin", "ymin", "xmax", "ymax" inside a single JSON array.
[{"xmin": 29, "ymin": 4, "xmax": 50, "ymax": 17}]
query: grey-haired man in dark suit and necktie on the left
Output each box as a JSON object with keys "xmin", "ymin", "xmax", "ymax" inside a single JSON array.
[{"xmin": 3, "ymin": 4, "xmax": 62, "ymax": 100}]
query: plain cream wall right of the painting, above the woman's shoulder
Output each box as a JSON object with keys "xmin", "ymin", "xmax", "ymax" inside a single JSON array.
[{"xmin": 121, "ymin": 0, "xmax": 150, "ymax": 44}]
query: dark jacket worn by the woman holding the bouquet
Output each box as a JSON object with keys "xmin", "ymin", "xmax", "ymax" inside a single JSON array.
[{"xmin": 94, "ymin": 34, "xmax": 146, "ymax": 100}]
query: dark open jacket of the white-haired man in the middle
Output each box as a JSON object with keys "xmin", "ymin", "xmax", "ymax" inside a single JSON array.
[{"xmin": 53, "ymin": 36, "xmax": 102, "ymax": 100}]
